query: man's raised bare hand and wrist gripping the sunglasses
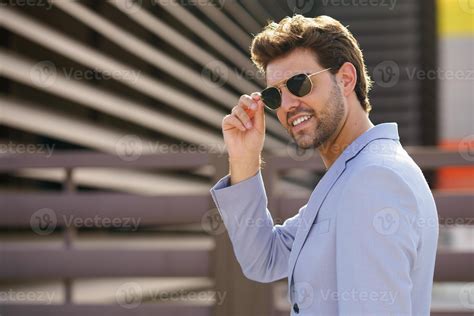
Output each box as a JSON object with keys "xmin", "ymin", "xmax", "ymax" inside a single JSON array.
[{"xmin": 222, "ymin": 92, "xmax": 265, "ymax": 184}]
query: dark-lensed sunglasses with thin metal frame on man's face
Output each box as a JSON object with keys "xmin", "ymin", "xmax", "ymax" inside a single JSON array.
[{"xmin": 260, "ymin": 68, "xmax": 331, "ymax": 111}]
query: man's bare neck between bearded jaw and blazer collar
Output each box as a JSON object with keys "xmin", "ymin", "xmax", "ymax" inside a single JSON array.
[{"xmin": 318, "ymin": 104, "xmax": 374, "ymax": 169}]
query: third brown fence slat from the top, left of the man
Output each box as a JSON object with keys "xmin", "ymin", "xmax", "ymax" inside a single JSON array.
[{"xmin": 0, "ymin": 247, "xmax": 211, "ymax": 280}]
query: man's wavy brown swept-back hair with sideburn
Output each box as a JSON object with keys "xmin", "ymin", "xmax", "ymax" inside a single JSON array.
[{"xmin": 250, "ymin": 15, "xmax": 372, "ymax": 112}]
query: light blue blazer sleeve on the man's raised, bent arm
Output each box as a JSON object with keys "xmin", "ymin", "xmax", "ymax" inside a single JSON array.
[{"xmin": 210, "ymin": 171, "xmax": 305, "ymax": 283}]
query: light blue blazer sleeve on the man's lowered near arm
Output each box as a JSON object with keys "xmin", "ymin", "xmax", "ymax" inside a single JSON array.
[{"xmin": 336, "ymin": 166, "xmax": 420, "ymax": 315}]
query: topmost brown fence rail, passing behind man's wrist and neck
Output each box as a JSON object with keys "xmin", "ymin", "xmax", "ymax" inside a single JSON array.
[{"xmin": 0, "ymin": 147, "xmax": 474, "ymax": 171}]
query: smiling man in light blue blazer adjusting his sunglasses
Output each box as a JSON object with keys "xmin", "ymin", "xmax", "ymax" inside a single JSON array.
[{"xmin": 211, "ymin": 15, "xmax": 438, "ymax": 315}]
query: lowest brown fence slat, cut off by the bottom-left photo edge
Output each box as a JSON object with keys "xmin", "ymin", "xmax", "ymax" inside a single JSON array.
[{"xmin": 0, "ymin": 304, "xmax": 213, "ymax": 316}]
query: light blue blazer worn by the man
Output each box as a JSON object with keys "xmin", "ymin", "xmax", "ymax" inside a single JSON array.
[{"xmin": 210, "ymin": 123, "xmax": 438, "ymax": 316}]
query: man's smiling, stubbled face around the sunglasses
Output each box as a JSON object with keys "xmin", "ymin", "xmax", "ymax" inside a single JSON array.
[{"xmin": 266, "ymin": 49, "xmax": 346, "ymax": 149}]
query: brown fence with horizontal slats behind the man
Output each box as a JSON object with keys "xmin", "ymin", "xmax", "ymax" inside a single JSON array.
[{"xmin": 0, "ymin": 148, "xmax": 474, "ymax": 316}]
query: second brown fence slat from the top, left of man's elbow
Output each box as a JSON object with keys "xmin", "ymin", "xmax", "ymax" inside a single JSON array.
[{"xmin": 0, "ymin": 192, "xmax": 211, "ymax": 228}]
